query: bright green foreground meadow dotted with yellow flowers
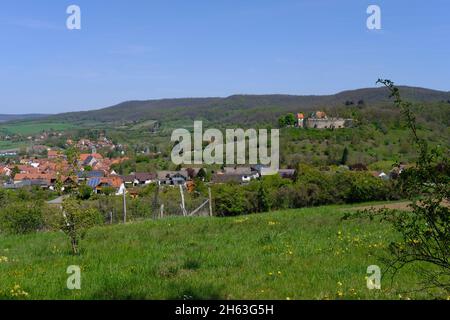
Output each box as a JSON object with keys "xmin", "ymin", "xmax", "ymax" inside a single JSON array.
[{"xmin": 0, "ymin": 202, "xmax": 443, "ymax": 300}]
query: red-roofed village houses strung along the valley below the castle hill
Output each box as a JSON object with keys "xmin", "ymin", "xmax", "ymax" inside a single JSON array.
[{"xmin": 0, "ymin": 145, "xmax": 295, "ymax": 195}]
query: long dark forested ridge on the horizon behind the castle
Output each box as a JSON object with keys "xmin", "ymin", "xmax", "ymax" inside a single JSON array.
[{"xmin": 44, "ymin": 87, "xmax": 450, "ymax": 124}]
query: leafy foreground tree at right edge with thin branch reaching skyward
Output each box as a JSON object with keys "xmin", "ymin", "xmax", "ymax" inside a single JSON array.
[{"xmin": 346, "ymin": 79, "xmax": 450, "ymax": 294}]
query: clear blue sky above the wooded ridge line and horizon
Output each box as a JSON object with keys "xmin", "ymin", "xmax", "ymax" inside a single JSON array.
[{"xmin": 0, "ymin": 0, "xmax": 450, "ymax": 113}]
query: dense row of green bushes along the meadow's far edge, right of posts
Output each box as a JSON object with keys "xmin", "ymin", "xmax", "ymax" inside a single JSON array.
[{"xmin": 213, "ymin": 165, "xmax": 402, "ymax": 216}]
